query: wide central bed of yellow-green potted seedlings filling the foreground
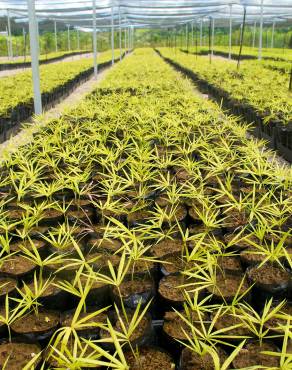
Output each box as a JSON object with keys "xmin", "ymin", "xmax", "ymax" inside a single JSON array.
[{"xmin": 0, "ymin": 49, "xmax": 292, "ymax": 370}]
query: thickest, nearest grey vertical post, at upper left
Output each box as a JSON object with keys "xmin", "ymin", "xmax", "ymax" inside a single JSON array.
[{"xmin": 27, "ymin": 0, "xmax": 42, "ymax": 114}]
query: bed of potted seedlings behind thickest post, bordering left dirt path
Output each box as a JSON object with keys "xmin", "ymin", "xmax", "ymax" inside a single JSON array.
[{"xmin": 0, "ymin": 51, "xmax": 124, "ymax": 134}]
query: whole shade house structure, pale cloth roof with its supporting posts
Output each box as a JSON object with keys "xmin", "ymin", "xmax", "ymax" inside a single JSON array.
[{"xmin": 0, "ymin": 0, "xmax": 292, "ymax": 114}]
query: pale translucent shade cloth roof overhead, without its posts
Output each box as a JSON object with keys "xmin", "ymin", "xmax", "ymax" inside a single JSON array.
[{"xmin": 0, "ymin": 0, "xmax": 292, "ymax": 29}]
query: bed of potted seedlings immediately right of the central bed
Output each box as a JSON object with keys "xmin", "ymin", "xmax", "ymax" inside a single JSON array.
[{"xmin": 159, "ymin": 49, "xmax": 292, "ymax": 161}]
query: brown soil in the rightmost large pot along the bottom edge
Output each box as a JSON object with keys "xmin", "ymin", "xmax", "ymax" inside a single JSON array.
[{"xmin": 233, "ymin": 342, "xmax": 279, "ymax": 369}]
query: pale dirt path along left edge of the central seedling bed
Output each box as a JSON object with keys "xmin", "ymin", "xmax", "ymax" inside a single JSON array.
[{"xmin": 0, "ymin": 62, "xmax": 115, "ymax": 162}]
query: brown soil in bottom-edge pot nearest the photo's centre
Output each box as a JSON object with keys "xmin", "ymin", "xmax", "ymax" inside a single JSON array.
[{"xmin": 125, "ymin": 347, "xmax": 174, "ymax": 370}]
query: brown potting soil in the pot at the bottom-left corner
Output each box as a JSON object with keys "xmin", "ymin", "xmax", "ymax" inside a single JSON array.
[{"xmin": 0, "ymin": 342, "xmax": 41, "ymax": 370}]
